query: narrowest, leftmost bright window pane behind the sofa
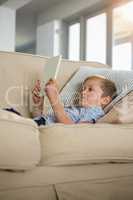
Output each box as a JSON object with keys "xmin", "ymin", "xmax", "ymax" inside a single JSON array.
[{"xmin": 68, "ymin": 23, "xmax": 80, "ymax": 60}]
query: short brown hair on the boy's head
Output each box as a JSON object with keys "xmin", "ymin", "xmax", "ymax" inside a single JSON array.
[{"xmin": 84, "ymin": 75, "xmax": 117, "ymax": 99}]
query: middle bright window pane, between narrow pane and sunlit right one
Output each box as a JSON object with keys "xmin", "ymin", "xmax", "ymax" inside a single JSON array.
[{"xmin": 86, "ymin": 13, "xmax": 106, "ymax": 63}]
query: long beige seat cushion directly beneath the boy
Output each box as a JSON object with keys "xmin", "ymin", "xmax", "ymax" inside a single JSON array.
[{"xmin": 40, "ymin": 124, "xmax": 133, "ymax": 166}]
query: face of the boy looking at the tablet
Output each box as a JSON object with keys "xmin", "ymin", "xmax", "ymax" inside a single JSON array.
[{"xmin": 80, "ymin": 79, "xmax": 108, "ymax": 107}]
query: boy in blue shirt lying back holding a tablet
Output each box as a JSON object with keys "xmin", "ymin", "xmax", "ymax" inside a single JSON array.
[{"xmin": 32, "ymin": 76, "xmax": 116, "ymax": 126}]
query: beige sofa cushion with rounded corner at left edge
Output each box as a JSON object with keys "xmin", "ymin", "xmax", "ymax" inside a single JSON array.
[{"xmin": 0, "ymin": 110, "xmax": 40, "ymax": 170}]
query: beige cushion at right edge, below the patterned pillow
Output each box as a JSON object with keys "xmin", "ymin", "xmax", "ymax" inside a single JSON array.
[{"xmin": 97, "ymin": 91, "xmax": 133, "ymax": 123}]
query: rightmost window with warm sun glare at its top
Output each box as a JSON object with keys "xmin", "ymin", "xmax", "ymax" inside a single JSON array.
[{"xmin": 113, "ymin": 2, "xmax": 133, "ymax": 70}]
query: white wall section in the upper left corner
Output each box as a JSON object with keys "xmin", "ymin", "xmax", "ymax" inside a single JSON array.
[{"xmin": 0, "ymin": 6, "xmax": 16, "ymax": 51}]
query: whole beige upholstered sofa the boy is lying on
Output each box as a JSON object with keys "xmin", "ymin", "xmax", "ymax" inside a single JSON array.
[{"xmin": 0, "ymin": 52, "xmax": 133, "ymax": 200}]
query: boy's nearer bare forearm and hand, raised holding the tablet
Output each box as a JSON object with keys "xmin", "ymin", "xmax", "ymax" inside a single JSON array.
[{"xmin": 45, "ymin": 79, "xmax": 74, "ymax": 124}]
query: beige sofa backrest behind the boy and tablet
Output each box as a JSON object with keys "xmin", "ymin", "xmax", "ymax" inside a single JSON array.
[{"xmin": 0, "ymin": 52, "xmax": 108, "ymax": 117}]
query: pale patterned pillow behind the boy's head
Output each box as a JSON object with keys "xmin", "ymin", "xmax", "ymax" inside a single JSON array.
[{"xmin": 45, "ymin": 67, "xmax": 133, "ymax": 115}]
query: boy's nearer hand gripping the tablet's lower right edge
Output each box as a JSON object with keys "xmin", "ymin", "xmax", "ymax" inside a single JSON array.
[{"xmin": 45, "ymin": 79, "xmax": 59, "ymax": 104}]
